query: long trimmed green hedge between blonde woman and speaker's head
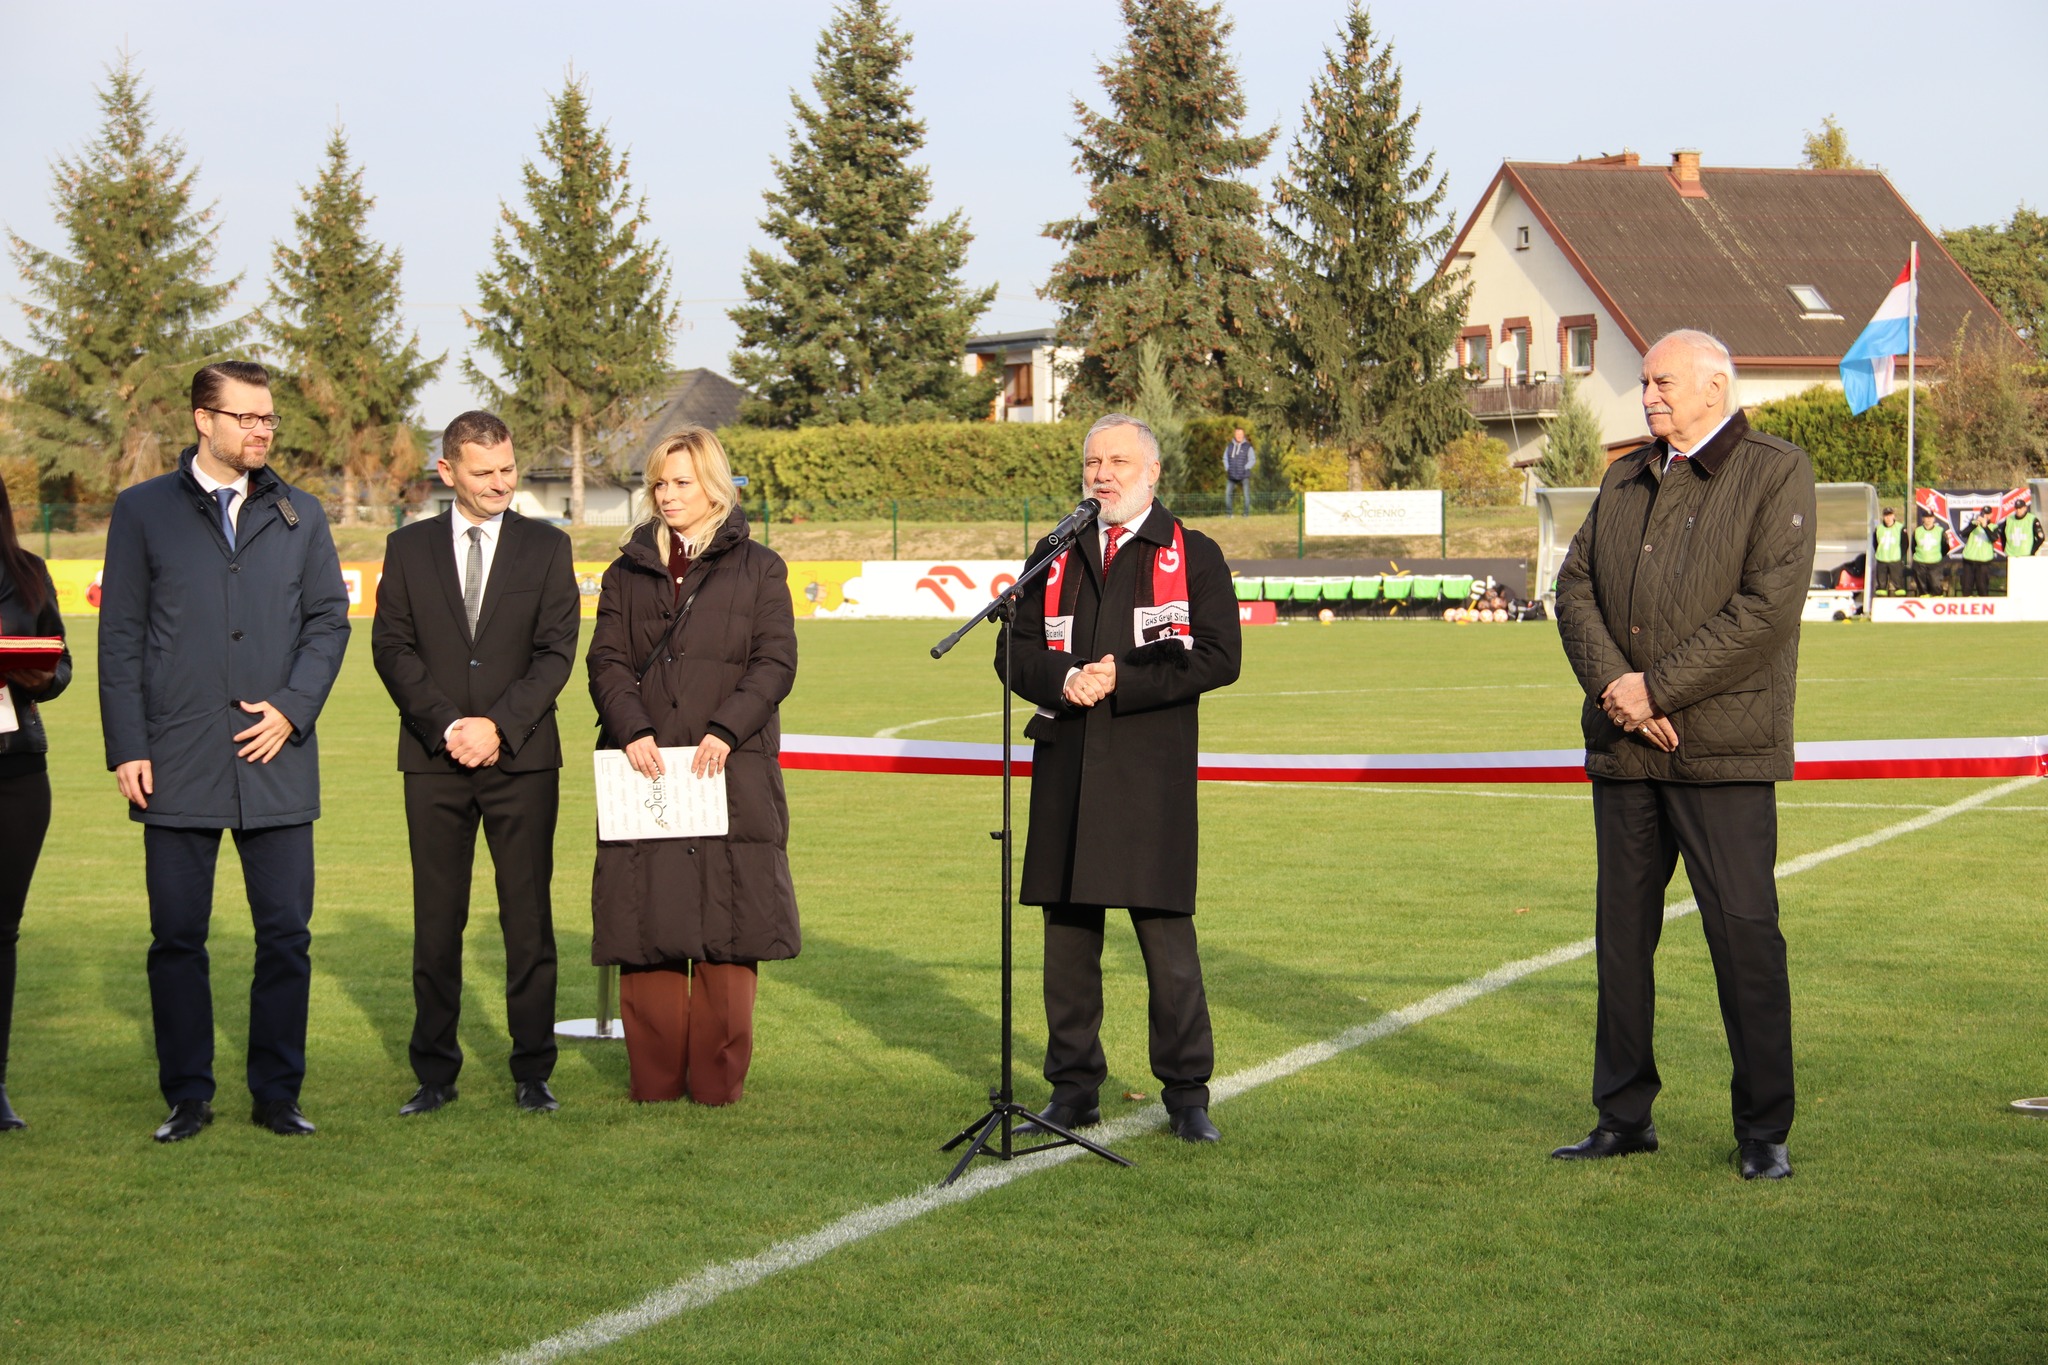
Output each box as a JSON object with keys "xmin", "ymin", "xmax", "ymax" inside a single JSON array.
[{"xmin": 719, "ymin": 422, "xmax": 1087, "ymax": 520}]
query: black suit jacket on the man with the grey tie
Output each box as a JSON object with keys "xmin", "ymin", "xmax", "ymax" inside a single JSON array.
[{"xmin": 371, "ymin": 512, "xmax": 582, "ymax": 774}]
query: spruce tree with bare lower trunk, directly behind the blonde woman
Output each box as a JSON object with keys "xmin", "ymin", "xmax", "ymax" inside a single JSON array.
[{"xmin": 463, "ymin": 72, "xmax": 676, "ymax": 526}]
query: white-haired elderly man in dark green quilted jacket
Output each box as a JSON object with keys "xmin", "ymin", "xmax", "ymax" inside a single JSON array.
[{"xmin": 1552, "ymin": 332, "xmax": 1815, "ymax": 1179}]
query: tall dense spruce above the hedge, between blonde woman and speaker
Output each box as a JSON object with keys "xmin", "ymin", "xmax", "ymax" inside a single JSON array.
[{"xmin": 731, "ymin": 0, "xmax": 1001, "ymax": 428}]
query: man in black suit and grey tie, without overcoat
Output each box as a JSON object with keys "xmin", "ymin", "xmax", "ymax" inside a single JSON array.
[{"xmin": 371, "ymin": 411, "xmax": 580, "ymax": 1115}]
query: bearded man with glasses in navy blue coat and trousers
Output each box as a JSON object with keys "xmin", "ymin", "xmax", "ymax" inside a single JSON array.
[{"xmin": 98, "ymin": 360, "xmax": 348, "ymax": 1142}]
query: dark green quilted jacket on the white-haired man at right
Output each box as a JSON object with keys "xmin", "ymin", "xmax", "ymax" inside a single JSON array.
[{"xmin": 1556, "ymin": 413, "xmax": 1815, "ymax": 782}]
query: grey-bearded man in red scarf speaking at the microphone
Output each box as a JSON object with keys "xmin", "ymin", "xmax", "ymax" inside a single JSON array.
[{"xmin": 995, "ymin": 413, "xmax": 1239, "ymax": 1142}]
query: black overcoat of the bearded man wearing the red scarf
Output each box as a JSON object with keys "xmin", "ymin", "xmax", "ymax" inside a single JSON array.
[{"xmin": 995, "ymin": 501, "xmax": 1243, "ymax": 915}]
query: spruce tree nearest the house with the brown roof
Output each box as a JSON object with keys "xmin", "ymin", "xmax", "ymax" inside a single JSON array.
[{"xmin": 1268, "ymin": 0, "xmax": 1473, "ymax": 489}]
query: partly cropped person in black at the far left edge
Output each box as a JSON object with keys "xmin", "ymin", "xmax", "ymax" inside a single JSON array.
[{"xmin": 0, "ymin": 485, "xmax": 72, "ymax": 1132}]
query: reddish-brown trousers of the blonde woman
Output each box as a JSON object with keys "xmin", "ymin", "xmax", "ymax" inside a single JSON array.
[{"xmin": 618, "ymin": 962, "xmax": 760, "ymax": 1105}]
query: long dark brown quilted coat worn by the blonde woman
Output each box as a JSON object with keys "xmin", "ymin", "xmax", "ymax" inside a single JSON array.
[{"xmin": 586, "ymin": 508, "xmax": 803, "ymax": 966}]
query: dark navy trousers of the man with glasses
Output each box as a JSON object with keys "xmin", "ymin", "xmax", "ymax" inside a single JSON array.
[{"xmin": 141, "ymin": 825, "xmax": 313, "ymax": 1103}]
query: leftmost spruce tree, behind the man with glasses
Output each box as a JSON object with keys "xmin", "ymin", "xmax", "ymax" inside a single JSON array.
[{"xmin": 4, "ymin": 55, "xmax": 244, "ymax": 499}]
